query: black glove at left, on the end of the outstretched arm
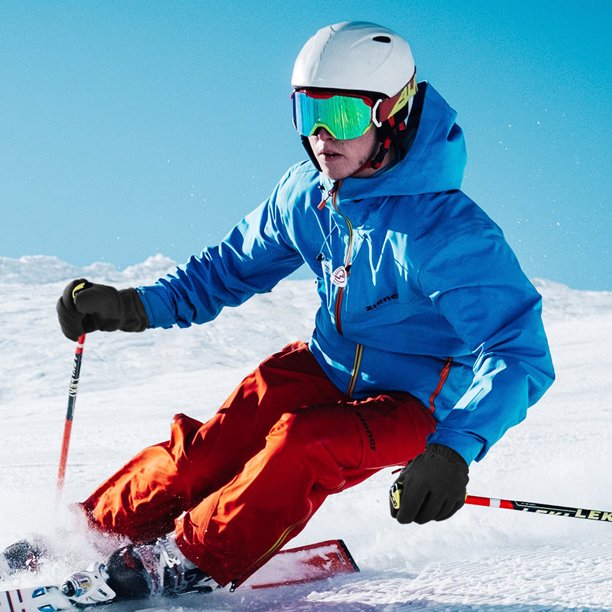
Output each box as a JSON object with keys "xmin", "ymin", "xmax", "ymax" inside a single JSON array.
[{"xmin": 56, "ymin": 278, "xmax": 149, "ymax": 342}]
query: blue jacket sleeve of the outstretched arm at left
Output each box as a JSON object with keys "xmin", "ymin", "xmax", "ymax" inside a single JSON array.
[{"xmin": 137, "ymin": 176, "xmax": 303, "ymax": 327}]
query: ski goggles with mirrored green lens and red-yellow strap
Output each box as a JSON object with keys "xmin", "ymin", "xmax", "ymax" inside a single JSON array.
[{"xmin": 291, "ymin": 71, "xmax": 417, "ymax": 140}]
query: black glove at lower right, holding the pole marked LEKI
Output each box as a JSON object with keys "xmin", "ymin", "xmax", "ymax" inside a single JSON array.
[{"xmin": 389, "ymin": 444, "xmax": 469, "ymax": 525}]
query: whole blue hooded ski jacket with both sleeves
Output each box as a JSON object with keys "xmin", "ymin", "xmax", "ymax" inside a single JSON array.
[{"xmin": 138, "ymin": 83, "xmax": 554, "ymax": 463}]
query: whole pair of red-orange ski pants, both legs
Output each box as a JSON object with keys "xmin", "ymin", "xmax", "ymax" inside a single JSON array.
[{"xmin": 82, "ymin": 342, "xmax": 435, "ymax": 585}]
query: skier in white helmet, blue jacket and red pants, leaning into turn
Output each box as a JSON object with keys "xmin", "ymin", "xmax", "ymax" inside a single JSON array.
[{"xmin": 14, "ymin": 22, "xmax": 554, "ymax": 604}]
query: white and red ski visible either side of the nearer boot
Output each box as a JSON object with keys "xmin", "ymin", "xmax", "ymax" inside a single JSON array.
[{"xmin": 0, "ymin": 540, "xmax": 359, "ymax": 612}]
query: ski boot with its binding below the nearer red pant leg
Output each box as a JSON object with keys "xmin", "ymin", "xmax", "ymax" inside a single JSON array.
[{"xmin": 62, "ymin": 536, "xmax": 214, "ymax": 606}]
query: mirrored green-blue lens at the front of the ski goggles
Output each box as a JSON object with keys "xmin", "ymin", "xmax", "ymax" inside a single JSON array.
[{"xmin": 291, "ymin": 91, "xmax": 372, "ymax": 140}]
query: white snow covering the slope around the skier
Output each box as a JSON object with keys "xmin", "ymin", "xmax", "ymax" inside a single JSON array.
[{"xmin": 0, "ymin": 255, "xmax": 612, "ymax": 611}]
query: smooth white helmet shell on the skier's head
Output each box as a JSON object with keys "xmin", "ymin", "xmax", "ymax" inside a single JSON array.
[{"xmin": 291, "ymin": 21, "xmax": 415, "ymax": 98}]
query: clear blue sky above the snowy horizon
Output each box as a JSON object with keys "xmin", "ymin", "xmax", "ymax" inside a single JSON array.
[{"xmin": 0, "ymin": 0, "xmax": 612, "ymax": 290}]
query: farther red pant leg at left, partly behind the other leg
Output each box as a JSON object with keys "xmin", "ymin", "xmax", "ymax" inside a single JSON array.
[{"xmin": 82, "ymin": 342, "xmax": 343, "ymax": 542}]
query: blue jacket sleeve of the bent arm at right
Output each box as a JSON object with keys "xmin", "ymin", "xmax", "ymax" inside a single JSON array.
[{"xmin": 419, "ymin": 225, "xmax": 554, "ymax": 463}]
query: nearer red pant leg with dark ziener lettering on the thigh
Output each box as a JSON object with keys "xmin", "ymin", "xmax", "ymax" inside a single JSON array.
[{"xmin": 175, "ymin": 394, "xmax": 435, "ymax": 585}]
